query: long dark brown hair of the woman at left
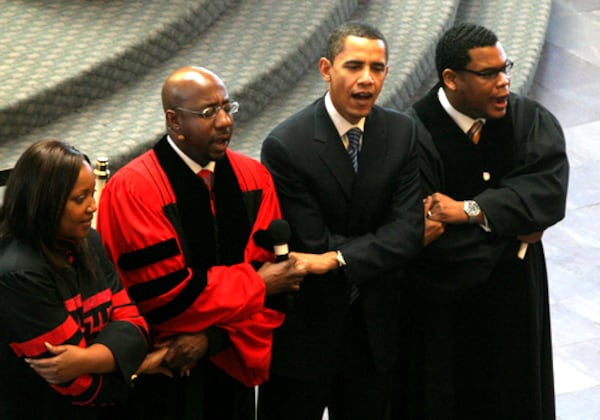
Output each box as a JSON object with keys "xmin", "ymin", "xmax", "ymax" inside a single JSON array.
[{"xmin": 0, "ymin": 140, "xmax": 93, "ymax": 272}]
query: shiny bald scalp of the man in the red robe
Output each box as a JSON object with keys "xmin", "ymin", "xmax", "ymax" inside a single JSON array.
[{"xmin": 162, "ymin": 66, "xmax": 225, "ymax": 111}]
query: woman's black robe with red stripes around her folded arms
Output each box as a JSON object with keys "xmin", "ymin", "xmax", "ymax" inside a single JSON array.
[{"xmin": 0, "ymin": 249, "xmax": 147, "ymax": 405}]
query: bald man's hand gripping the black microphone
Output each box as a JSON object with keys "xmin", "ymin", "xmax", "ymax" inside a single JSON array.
[{"xmin": 258, "ymin": 253, "xmax": 307, "ymax": 295}]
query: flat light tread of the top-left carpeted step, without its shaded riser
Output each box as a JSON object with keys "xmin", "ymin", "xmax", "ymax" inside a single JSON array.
[{"xmin": 0, "ymin": 0, "xmax": 231, "ymax": 109}]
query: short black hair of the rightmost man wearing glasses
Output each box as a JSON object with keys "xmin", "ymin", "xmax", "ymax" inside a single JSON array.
[{"xmin": 435, "ymin": 23, "xmax": 498, "ymax": 85}]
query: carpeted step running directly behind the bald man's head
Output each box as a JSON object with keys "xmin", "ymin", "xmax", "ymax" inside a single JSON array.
[{"xmin": 0, "ymin": 0, "xmax": 358, "ymax": 172}]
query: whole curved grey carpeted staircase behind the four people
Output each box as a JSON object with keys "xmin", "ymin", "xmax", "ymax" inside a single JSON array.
[{"xmin": 0, "ymin": 0, "xmax": 551, "ymax": 172}]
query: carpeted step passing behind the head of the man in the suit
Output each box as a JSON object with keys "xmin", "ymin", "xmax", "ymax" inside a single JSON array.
[{"xmin": 231, "ymin": 0, "xmax": 459, "ymax": 158}]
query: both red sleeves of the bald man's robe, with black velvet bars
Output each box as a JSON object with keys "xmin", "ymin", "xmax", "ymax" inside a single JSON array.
[{"xmin": 98, "ymin": 153, "xmax": 283, "ymax": 386}]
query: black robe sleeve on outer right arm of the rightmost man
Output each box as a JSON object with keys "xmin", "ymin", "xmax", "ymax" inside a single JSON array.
[{"xmin": 474, "ymin": 98, "xmax": 569, "ymax": 237}]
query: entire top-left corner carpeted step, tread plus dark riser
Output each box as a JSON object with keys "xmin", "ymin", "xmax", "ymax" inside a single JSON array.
[{"xmin": 0, "ymin": 0, "xmax": 232, "ymax": 141}]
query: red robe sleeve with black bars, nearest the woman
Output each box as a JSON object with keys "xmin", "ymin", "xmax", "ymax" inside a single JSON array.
[{"xmin": 98, "ymin": 168, "xmax": 265, "ymax": 339}]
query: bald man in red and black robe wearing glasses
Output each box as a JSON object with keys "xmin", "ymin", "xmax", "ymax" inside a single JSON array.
[{"xmin": 98, "ymin": 67, "xmax": 304, "ymax": 419}]
